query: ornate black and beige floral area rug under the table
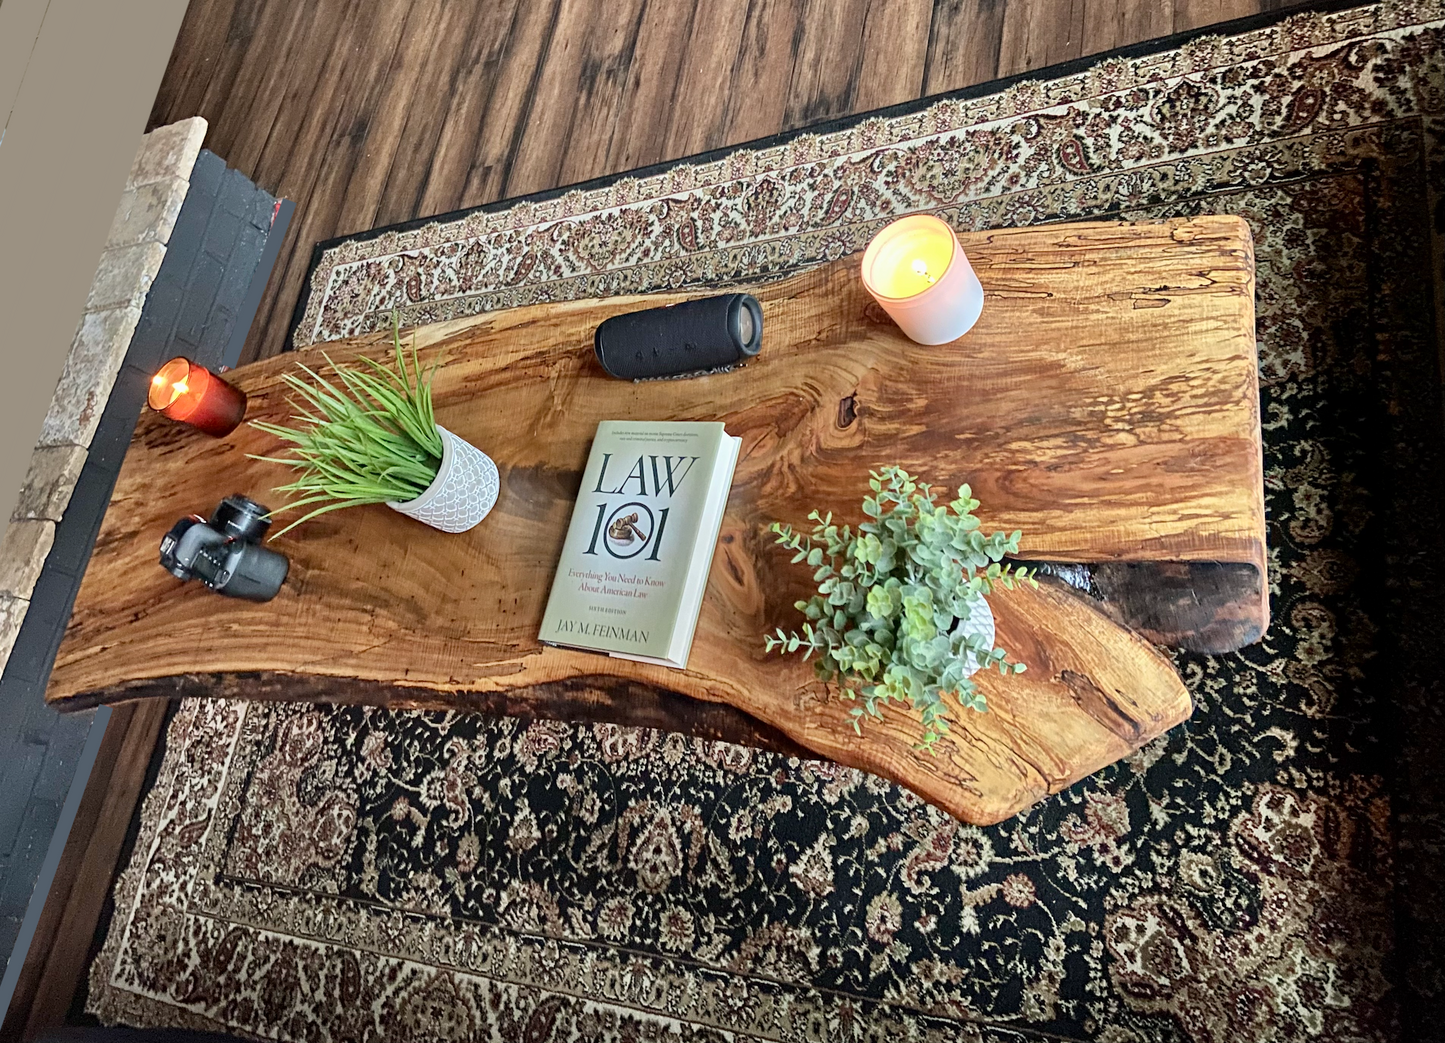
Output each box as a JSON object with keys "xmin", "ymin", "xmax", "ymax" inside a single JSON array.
[{"xmin": 87, "ymin": 0, "xmax": 1445, "ymax": 1043}]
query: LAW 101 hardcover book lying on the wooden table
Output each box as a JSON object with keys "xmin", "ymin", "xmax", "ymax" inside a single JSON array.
[{"xmin": 538, "ymin": 420, "xmax": 743, "ymax": 670}]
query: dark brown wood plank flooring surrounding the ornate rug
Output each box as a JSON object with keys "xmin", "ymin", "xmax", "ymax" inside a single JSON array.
[{"xmin": 0, "ymin": 0, "xmax": 1312, "ymax": 1039}]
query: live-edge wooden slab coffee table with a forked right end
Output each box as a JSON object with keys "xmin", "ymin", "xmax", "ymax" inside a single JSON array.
[{"xmin": 46, "ymin": 217, "xmax": 1267, "ymax": 823}]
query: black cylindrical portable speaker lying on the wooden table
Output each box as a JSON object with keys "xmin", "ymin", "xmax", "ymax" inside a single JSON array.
[{"xmin": 592, "ymin": 293, "xmax": 763, "ymax": 380}]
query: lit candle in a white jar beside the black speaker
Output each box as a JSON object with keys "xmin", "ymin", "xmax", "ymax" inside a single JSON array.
[{"xmin": 863, "ymin": 214, "xmax": 984, "ymax": 344}]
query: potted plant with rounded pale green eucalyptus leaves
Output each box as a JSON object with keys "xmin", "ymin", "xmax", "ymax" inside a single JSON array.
[{"xmin": 764, "ymin": 467, "xmax": 1038, "ymax": 748}]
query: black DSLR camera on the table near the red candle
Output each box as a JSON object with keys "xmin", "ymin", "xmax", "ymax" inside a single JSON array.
[{"xmin": 160, "ymin": 493, "xmax": 290, "ymax": 601}]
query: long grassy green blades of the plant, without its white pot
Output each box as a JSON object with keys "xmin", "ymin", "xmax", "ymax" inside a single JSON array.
[{"xmin": 251, "ymin": 311, "xmax": 442, "ymax": 539}]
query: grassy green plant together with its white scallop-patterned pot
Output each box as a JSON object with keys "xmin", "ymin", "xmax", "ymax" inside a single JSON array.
[{"xmin": 253, "ymin": 312, "xmax": 500, "ymax": 536}]
